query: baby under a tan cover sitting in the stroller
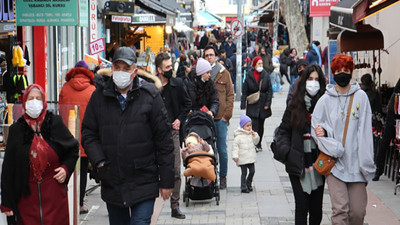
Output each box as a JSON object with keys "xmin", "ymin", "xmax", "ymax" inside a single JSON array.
[{"xmin": 182, "ymin": 132, "xmax": 216, "ymax": 181}]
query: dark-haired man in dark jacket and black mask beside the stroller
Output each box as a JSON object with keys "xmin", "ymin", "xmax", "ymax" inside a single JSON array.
[{"xmin": 155, "ymin": 52, "xmax": 192, "ymax": 219}]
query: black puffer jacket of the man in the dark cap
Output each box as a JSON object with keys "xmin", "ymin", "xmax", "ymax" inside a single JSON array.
[{"xmin": 82, "ymin": 76, "xmax": 174, "ymax": 207}]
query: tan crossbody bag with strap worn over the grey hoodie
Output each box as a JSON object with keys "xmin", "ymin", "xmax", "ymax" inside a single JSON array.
[{"xmin": 314, "ymin": 94, "xmax": 354, "ymax": 176}]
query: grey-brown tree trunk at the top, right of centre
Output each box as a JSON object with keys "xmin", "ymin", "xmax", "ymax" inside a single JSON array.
[{"xmin": 279, "ymin": 0, "xmax": 309, "ymax": 56}]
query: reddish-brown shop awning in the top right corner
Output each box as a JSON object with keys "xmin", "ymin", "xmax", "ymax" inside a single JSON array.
[{"xmin": 353, "ymin": 0, "xmax": 400, "ymax": 23}]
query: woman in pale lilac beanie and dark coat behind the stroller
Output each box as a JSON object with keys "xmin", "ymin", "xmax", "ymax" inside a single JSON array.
[{"xmin": 185, "ymin": 58, "xmax": 219, "ymax": 117}]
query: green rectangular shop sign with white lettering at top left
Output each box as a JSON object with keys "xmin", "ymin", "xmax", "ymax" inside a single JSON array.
[{"xmin": 16, "ymin": 0, "xmax": 78, "ymax": 26}]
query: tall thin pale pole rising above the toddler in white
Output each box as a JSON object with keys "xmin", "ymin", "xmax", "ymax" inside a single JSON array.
[{"xmin": 235, "ymin": 0, "xmax": 245, "ymax": 101}]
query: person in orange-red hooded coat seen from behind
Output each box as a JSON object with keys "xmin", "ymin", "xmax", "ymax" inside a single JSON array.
[{"xmin": 59, "ymin": 61, "xmax": 96, "ymax": 214}]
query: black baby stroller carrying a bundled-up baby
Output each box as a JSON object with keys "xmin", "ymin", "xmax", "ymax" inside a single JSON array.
[{"xmin": 182, "ymin": 111, "xmax": 220, "ymax": 206}]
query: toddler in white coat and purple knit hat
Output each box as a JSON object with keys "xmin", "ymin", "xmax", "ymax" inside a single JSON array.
[{"xmin": 232, "ymin": 114, "xmax": 260, "ymax": 193}]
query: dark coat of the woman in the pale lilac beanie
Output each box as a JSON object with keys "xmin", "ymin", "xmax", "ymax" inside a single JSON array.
[{"xmin": 184, "ymin": 76, "xmax": 219, "ymax": 115}]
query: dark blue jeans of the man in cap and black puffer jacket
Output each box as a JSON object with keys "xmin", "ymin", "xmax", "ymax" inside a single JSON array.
[{"xmin": 107, "ymin": 199, "xmax": 155, "ymax": 225}]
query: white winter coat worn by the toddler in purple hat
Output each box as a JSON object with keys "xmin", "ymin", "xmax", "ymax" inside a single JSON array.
[{"xmin": 232, "ymin": 128, "xmax": 260, "ymax": 166}]
